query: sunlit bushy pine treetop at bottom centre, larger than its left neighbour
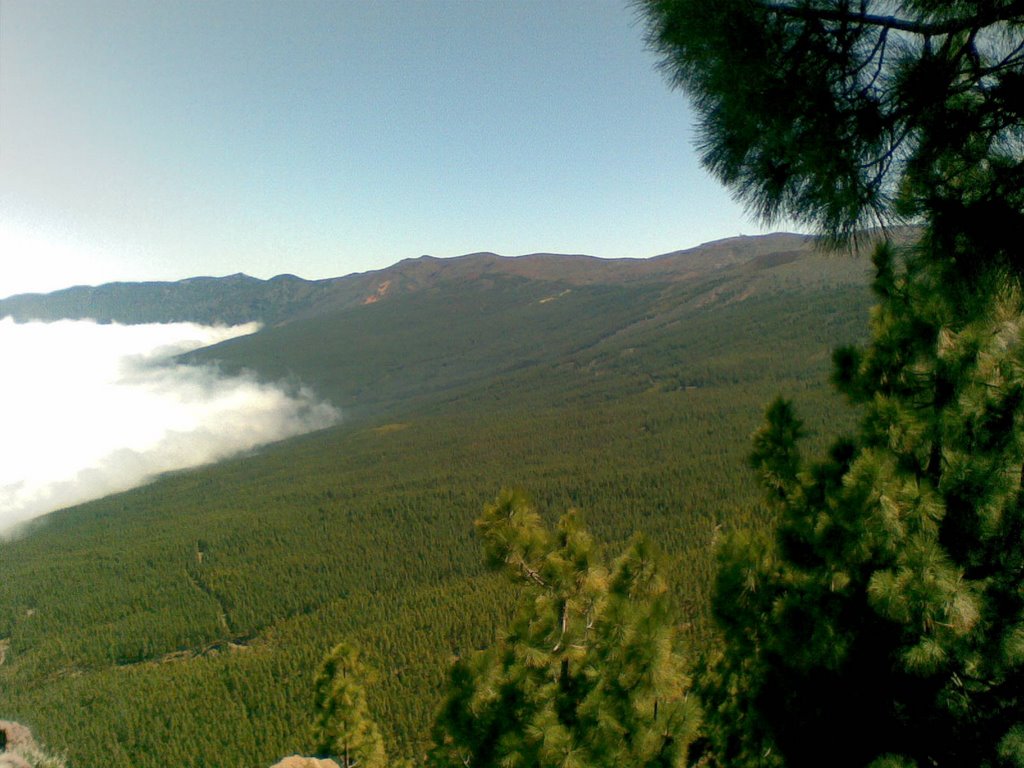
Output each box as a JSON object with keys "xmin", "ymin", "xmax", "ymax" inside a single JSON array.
[{"xmin": 431, "ymin": 492, "xmax": 699, "ymax": 768}]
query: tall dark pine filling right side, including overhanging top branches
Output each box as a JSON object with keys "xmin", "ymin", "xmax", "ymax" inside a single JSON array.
[{"xmin": 642, "ymin": 0, "xmax": 1024, "ymax": 768}]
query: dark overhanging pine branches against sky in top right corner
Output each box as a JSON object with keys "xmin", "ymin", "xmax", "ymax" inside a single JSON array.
[{"xmin": 638, "ymin": 0, "xmax": 1024, "ymax": 262}]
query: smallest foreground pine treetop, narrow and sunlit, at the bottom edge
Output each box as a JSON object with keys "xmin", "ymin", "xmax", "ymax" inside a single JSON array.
[{"xmin": 312, "ymin": 643, "xmax": 387, "ymax": 768}]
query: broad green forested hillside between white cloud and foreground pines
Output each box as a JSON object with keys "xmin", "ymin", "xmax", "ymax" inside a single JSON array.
[{"xmin": 0, "ymin": 237, "xmax": 867, "ymax": 768}]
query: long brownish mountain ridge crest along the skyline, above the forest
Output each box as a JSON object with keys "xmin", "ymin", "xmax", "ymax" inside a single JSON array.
[{"xmin": 0, "ymin": 233, "xmax": 847, "ymax": 326}]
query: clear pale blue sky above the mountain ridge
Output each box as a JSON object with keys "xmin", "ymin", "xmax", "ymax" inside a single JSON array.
[{"xmin": 0, "ymin": 0, "xmax": 790, "ymax": 296}]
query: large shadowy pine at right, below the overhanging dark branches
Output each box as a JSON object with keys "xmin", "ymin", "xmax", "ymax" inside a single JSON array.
[{"xmin": 703, "ymin": 240, "xmax": 1024, "ymax": 766}]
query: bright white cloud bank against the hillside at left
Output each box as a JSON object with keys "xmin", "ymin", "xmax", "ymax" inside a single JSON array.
[{"xmin": 0, "ymin": 317, "xmax": 339, "ymax": 531}]
